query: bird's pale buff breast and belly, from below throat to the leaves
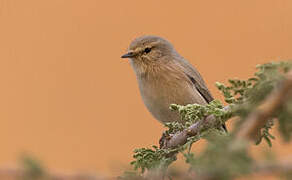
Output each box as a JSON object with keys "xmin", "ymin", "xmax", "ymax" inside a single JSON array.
[{"xmin": 137, "ymin": 68, "xmax": 206, "ymax": 123}]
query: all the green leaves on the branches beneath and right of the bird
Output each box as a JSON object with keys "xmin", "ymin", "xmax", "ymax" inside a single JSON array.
[{"xmin": 126, "ymin": 62, "xmax": 292, "ymax": 180}]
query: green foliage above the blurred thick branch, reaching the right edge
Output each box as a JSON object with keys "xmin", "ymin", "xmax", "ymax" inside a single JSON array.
[{"xmin": 216, "ymin": 61, "xmax": 292, "ymax": 108}]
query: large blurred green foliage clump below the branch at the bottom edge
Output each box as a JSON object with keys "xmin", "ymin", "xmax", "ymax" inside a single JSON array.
[{"xmin": 184, "ymin": 132, "xmax": 253, "ymax": 180}]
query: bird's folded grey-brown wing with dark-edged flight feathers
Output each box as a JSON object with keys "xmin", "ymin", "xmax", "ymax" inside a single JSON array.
[{"xmin": 179, "ymin": 58, "xmax": 214, "ymax": 103}]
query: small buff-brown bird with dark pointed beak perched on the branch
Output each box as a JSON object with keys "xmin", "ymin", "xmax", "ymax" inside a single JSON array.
[{"xmin": 121, "ymin": 35, "xmax": 227, "ymax": 131}]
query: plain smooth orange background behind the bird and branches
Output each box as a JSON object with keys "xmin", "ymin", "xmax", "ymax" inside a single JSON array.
[{"xmin": 0, "ymin": 0, "xmax": 292, "ymax": 175}]
